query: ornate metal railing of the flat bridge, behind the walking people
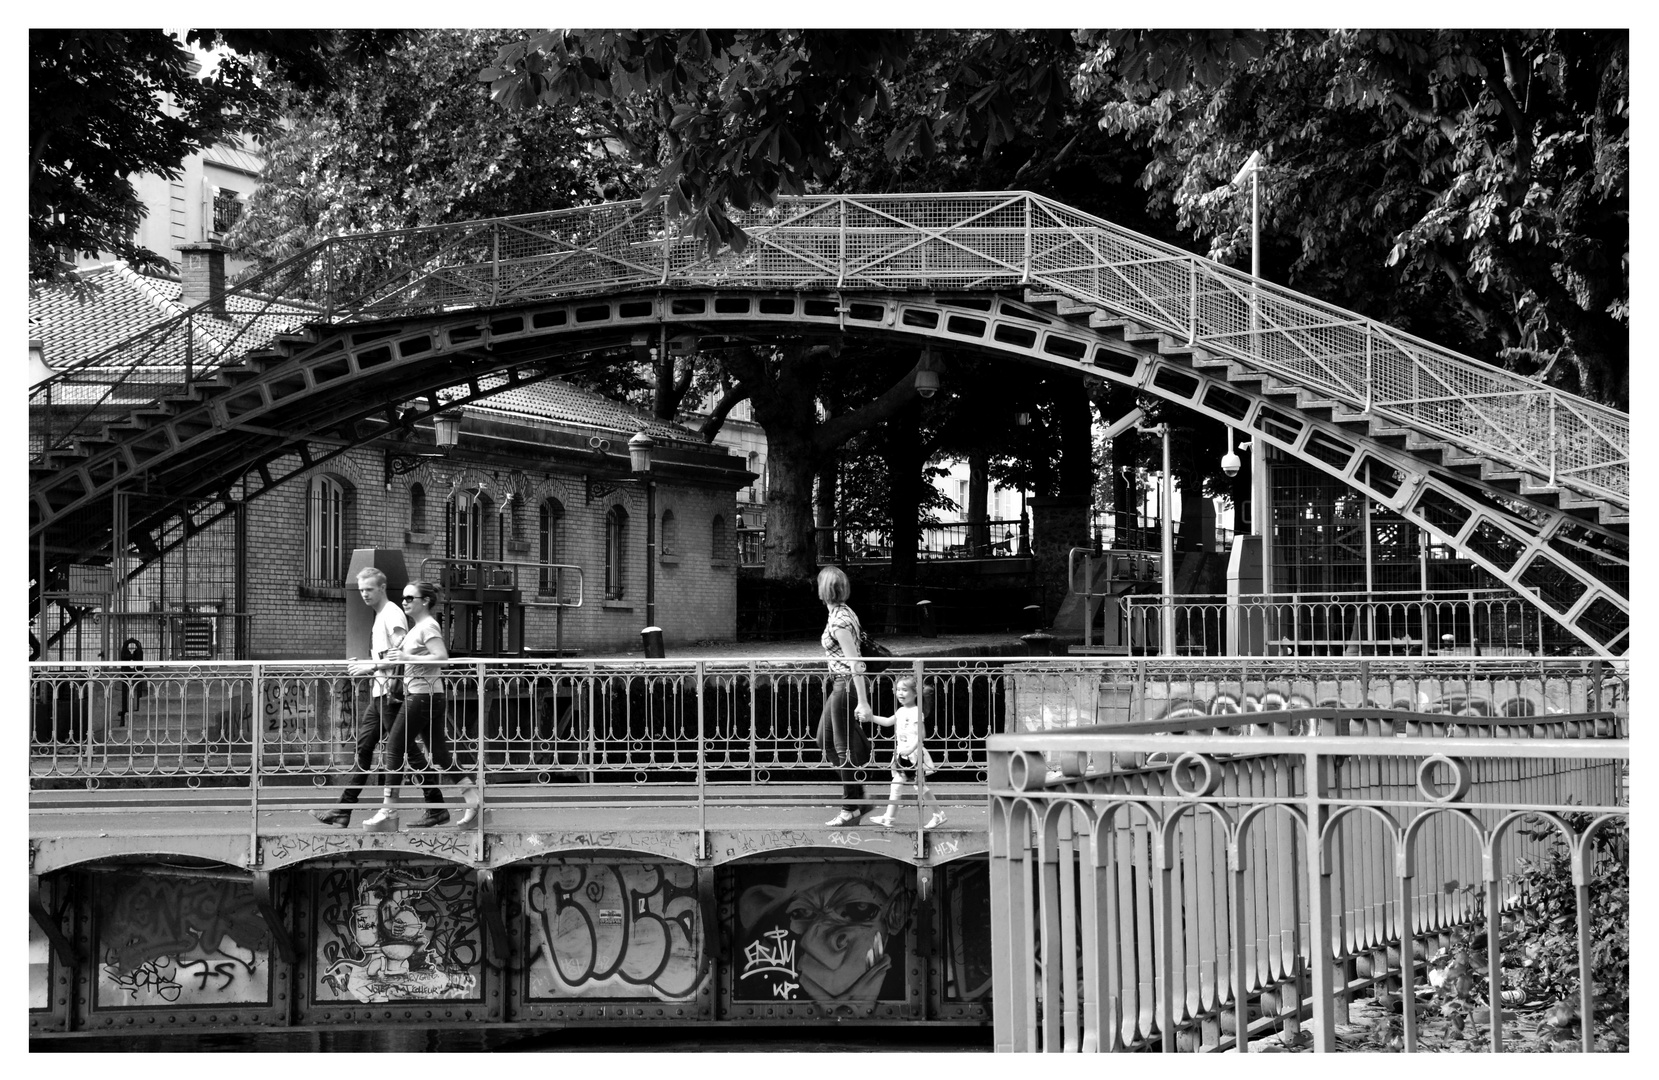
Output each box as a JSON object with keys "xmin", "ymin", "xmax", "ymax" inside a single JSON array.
[{"xmin": 30, "ymin": 657, "xmax": 1629, "ymax": 798}]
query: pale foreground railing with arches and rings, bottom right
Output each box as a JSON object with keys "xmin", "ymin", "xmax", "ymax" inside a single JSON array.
[{"xmin": 989, "ymin": 708, "xmax": 1629, "ymax": 1052}]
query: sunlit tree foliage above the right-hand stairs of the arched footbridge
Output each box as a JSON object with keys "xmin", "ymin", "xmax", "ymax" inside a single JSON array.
[{"xmin": 1075, "ymin": 30, "xmax": 1629, "ymax": 406}]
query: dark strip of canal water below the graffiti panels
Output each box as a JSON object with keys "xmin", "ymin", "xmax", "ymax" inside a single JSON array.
[{"xmin": 28, "ymin": 1027, "xmax": 992, "ymax": 1053}]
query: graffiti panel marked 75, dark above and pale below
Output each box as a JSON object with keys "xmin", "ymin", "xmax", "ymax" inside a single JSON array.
[{"xmin": 96, "ymin": 874, "xmax": 270, "ymax": 1009}]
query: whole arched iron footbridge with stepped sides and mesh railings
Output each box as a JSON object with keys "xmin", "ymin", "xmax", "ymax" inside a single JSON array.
[{"xmin": 30, "ymin": 192, "xmax": 1629, "ymax": 654}]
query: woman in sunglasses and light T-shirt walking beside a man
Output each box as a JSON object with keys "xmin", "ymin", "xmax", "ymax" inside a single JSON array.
[{"xmin": 363, "ymin": 581, "xmax": 478, "ymax": 828}]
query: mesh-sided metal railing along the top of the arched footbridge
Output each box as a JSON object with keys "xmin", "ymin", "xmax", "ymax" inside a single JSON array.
[{"xmin": 30, "ymin": 192, "xmax": 1629, "ymax": 506}]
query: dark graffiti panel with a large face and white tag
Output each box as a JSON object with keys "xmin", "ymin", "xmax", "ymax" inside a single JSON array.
[{"xmin": 732, "ymin": 861, "xmax": 916, "ymax": 1017}]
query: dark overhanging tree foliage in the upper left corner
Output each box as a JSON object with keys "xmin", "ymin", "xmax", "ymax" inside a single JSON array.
[{"xmin": 28, "ymin": 30, "xmax": 397, "ymax": 284}]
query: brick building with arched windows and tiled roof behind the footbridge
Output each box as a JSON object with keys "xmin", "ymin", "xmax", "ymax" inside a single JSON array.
[{"xmin": 30, "ymin": 262, "xmax": 755, "ymax": 659}]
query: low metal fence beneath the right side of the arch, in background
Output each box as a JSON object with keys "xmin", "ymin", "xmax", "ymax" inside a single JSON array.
[{"xmin": 1118, "ymin": 589, "xmax": 1546, "ymax": 657}]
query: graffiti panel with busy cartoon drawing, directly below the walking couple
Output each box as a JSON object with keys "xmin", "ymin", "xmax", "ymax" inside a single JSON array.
[{"xmin": 312, "ymin": 868, "xmax": 483, "ymax": 1004}]
